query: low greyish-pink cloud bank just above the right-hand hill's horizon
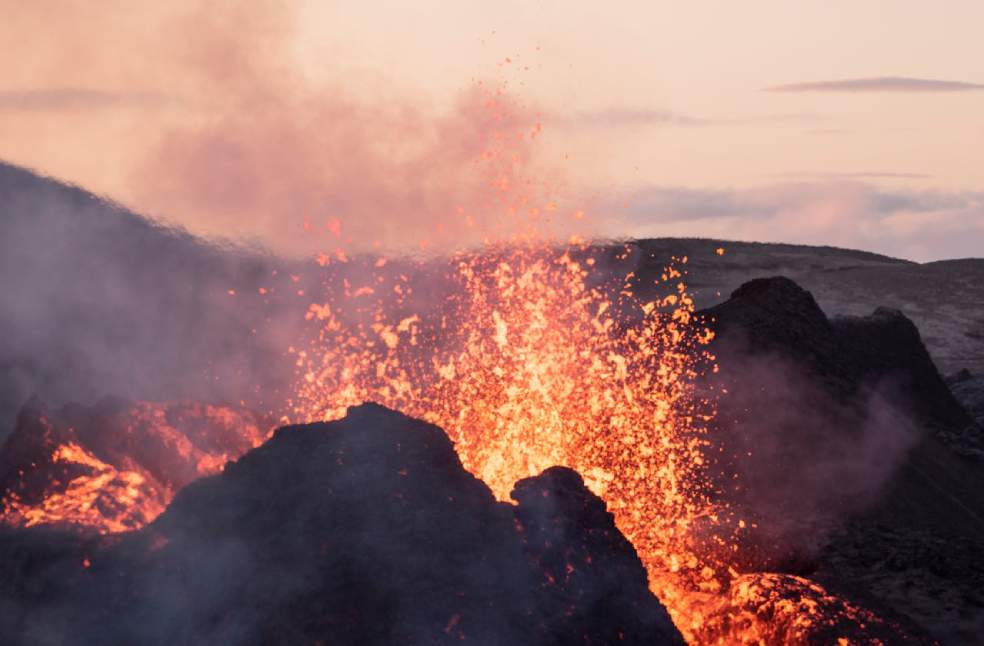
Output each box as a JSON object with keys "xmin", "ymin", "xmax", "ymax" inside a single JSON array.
[{"xmin": 609, "ymin": 181, "xmax": 984, "ymax": 261}]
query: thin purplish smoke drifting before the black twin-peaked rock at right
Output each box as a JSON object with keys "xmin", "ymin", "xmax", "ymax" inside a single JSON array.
[{"xmin": 712, "ymin": 352, "xmax": 919, "ymax": 568}]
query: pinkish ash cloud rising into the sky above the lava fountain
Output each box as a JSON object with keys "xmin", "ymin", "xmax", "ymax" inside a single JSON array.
[{"xmin": 121, "ymin": 4, "xmax": 568, "ymax": 253}]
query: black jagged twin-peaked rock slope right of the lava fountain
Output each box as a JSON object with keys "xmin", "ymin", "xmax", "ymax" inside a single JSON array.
[{"xmin": 703, "ymin": 277, "xmax": 984, "ymax": 643}]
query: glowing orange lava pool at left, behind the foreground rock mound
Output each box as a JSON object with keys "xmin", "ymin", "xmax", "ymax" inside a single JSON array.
[{"xmin": 0, "ymin": 402, "xmax": 270, "ymax": 534}]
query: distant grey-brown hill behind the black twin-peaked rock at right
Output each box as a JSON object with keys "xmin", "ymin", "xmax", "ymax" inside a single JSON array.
[{"xmin": 637, "ymin": 238, "xmax": 984, "ymax": 374}]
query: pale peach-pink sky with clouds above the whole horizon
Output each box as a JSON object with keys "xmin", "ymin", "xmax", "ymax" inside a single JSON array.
[{"xmin": 0, "ymin": 0, "xmax": 984, "ymax": 260}]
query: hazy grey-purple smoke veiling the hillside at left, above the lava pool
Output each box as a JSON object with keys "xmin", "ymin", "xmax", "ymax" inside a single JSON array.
[{"xmin": 0, "ymin": 166, "xmax": 303, "ymax": 446}]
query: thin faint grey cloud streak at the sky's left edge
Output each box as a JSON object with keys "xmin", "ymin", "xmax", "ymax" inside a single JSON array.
[{"xmin": 0, "ymin": 87, "xmax": 168, "ymax": 112}]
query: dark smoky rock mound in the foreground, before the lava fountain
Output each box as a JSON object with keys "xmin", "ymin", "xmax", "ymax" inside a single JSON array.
[{"xmin": 0, "ymin": 405, "xmax": 681, "ymax": 645}]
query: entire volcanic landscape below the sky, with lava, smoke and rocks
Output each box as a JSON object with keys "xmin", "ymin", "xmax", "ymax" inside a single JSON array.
[{"xmin": 0, "ymin": 166, "xmax": 984, "ymax": 644}]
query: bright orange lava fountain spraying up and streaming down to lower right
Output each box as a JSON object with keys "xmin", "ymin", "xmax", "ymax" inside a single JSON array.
[{"xmin": 292, "ymin": 244, "xmax": 904, "ymax": 644}]
